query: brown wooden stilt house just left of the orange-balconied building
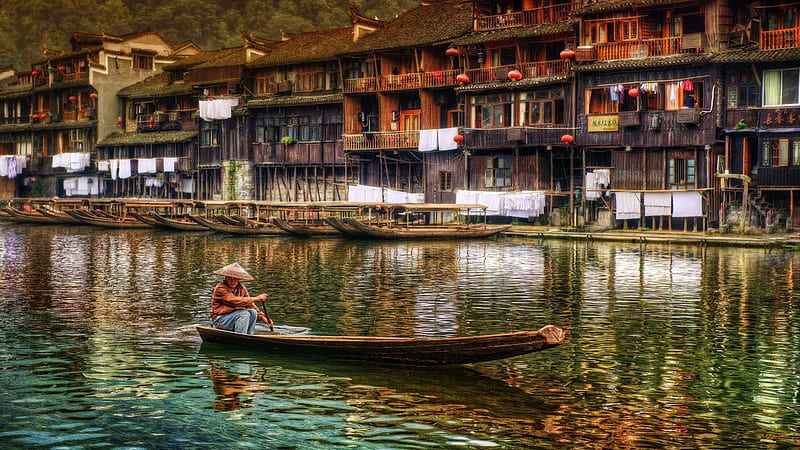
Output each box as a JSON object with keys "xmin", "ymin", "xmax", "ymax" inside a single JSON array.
[{"xmin": 246, "ymin": 28, "xmax": 358, "ymax": 202}]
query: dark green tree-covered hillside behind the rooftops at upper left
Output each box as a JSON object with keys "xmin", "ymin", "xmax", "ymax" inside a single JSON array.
[{"xmin": 0, "ymin": 0, "xmax": 419, "ymax": 70}]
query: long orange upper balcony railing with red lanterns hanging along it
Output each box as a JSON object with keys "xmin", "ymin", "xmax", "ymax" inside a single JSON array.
[{"xmin": 344, "ymin": 59, "xmax": 569, "ymax": 94}]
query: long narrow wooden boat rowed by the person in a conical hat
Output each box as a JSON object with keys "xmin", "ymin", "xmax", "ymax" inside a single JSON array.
[{"xmin": 197, "ymin": 325, "xmax": 566, "ymax": 366}]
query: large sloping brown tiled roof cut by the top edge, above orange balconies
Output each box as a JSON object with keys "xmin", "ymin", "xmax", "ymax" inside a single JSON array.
[{"xmin": 340, "ymin": 0, "xmax": 472, "ymax": 55}]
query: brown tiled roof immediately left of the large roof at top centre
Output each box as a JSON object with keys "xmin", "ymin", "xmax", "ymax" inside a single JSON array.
[{"xmin": 247, "ymin": 27, "xmax": 353, "ymax": 69}]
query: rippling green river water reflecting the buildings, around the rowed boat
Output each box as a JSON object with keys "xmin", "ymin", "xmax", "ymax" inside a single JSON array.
[{"xmin": 0, "ymin": 224, "xmax": 800, "ymax": 449}]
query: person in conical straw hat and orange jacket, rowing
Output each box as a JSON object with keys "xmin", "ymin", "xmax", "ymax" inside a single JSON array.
[{"xmin": 211, "ymin": 263, "xmax": 273, "ymax": 334}]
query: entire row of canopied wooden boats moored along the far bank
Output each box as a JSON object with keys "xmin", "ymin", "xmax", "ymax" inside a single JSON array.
[{"xmin": 0, "ymin": 198, "xmax": 510, "ymax": 239}]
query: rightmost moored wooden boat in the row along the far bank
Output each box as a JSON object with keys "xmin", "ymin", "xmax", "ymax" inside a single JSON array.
[{"xmin": 342, "ymin": 217, "xmax": 511, "ymax": 239}]
